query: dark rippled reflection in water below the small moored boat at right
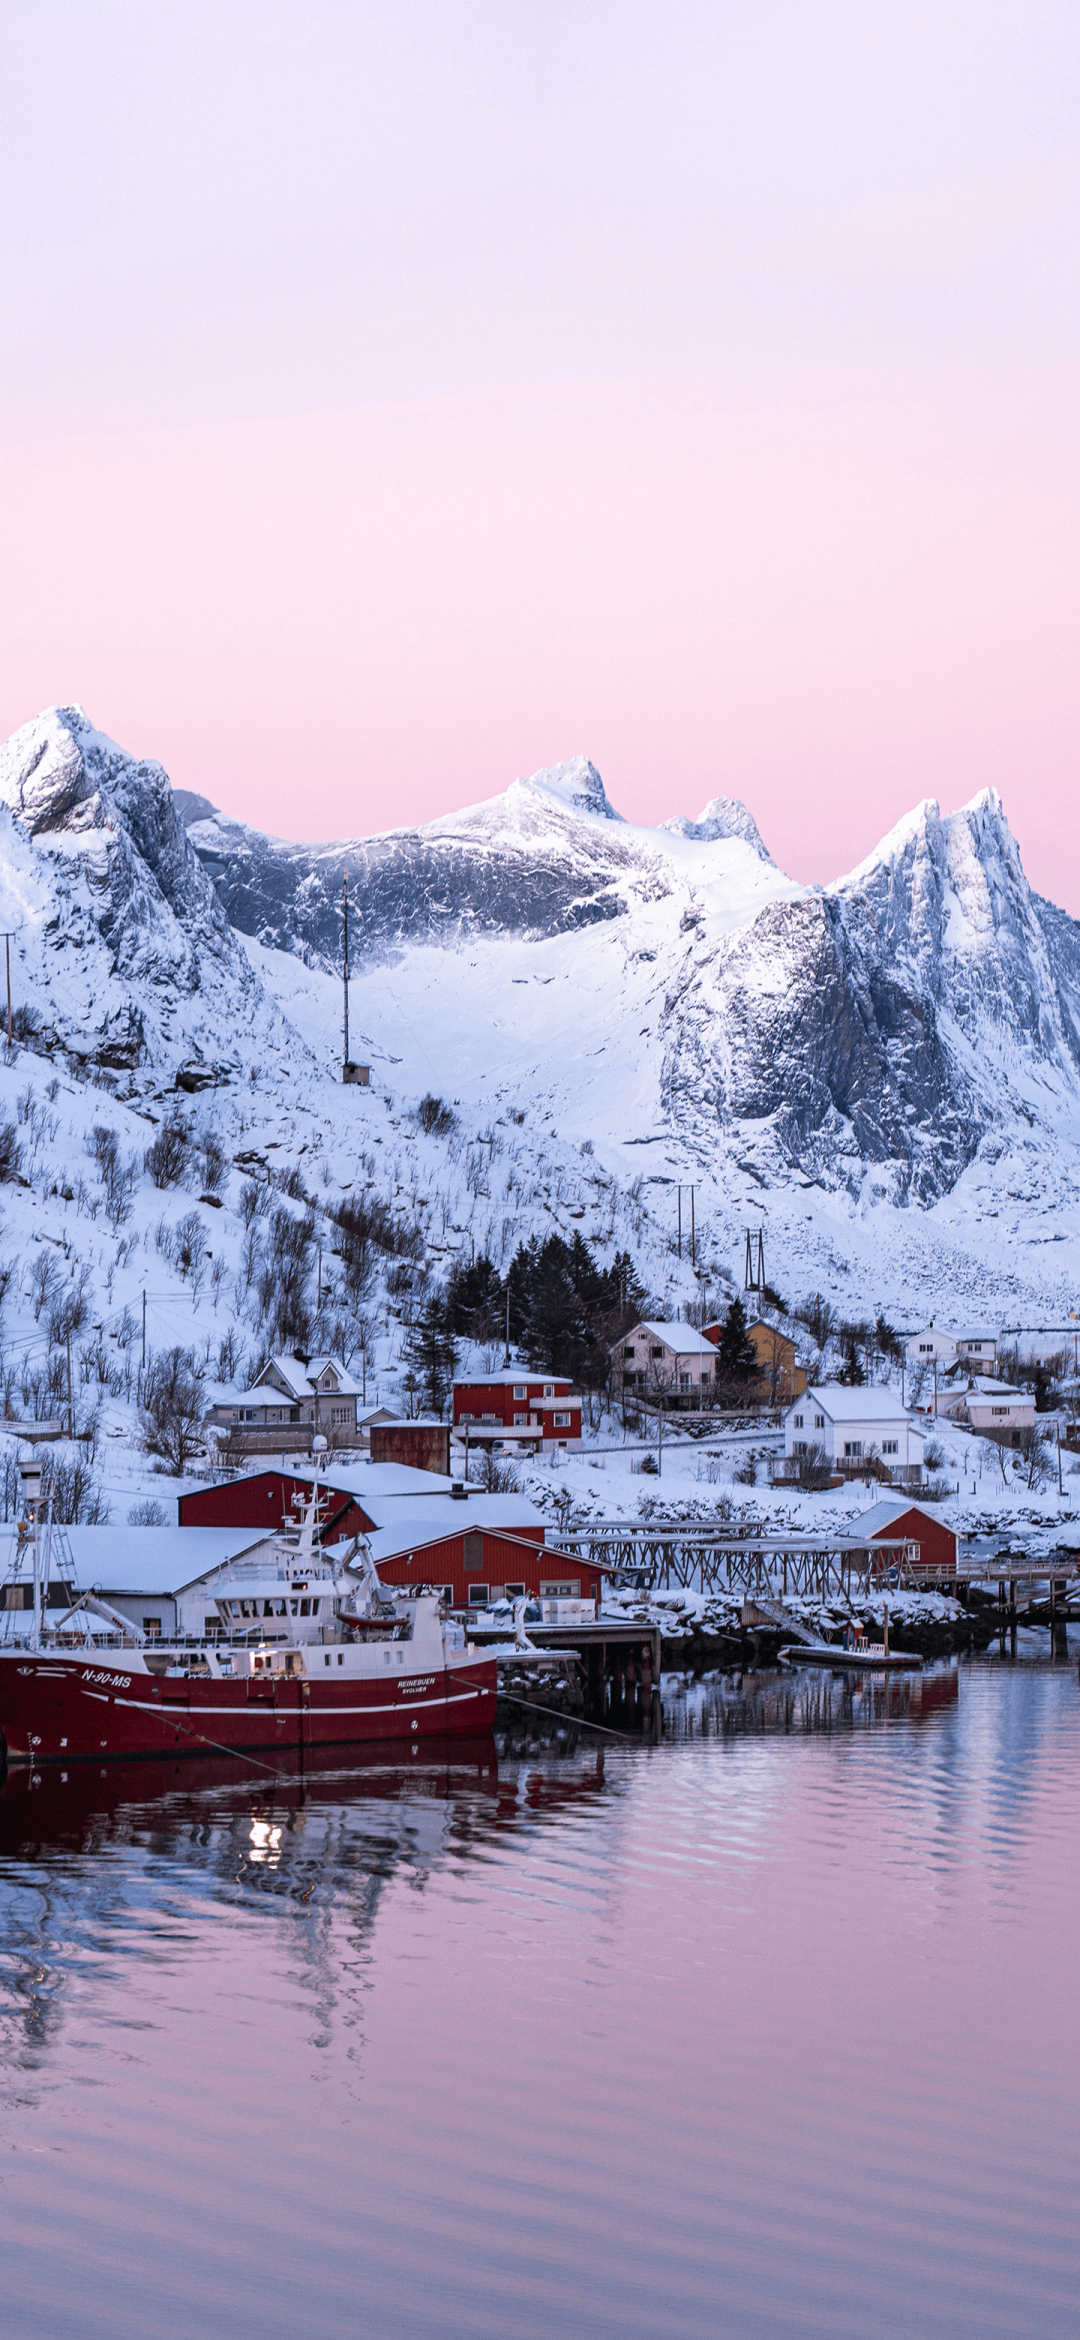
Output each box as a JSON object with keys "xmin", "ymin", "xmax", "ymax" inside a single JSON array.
[{"xmin": 664, "ymin": 1661, "xmax": 961, "ymax": 1741}]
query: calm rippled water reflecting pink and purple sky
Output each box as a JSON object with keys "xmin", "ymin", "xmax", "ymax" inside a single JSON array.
[{"xmin": 0, "ymin": 1664, "xmax": 1080, "ymax": 2340}]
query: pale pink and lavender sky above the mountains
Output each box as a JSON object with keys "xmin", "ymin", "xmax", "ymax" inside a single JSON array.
[{"xmin": 0, "ymin": 0, "xmax": 1080, "ymax": 910}]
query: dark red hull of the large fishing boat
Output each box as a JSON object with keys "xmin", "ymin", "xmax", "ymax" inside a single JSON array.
[{"xmin": 0, "ymin": 1652, "xmax": 498, "ymax": 1764}]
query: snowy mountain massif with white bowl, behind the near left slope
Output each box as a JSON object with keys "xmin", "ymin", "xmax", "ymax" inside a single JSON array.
[{"xmin": 187, "ymin": 734, "xmax": 1080, "ymax": 1317}]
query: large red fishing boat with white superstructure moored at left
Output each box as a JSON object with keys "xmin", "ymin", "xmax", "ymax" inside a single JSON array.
[{"xmin": 0, "ymin": 1491, "xmax": 498, "ymax": 1764}]
